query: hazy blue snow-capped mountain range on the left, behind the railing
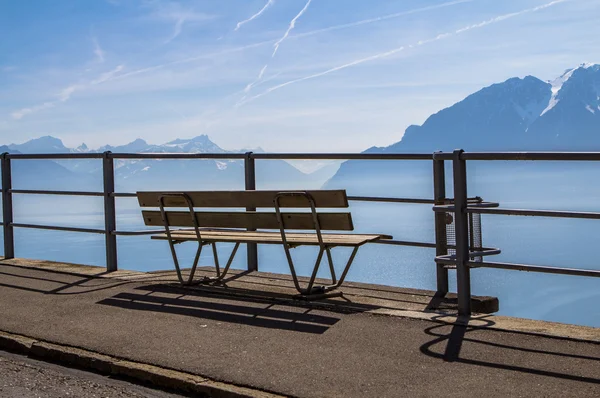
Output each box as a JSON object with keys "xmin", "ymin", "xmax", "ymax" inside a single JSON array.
[{"xmin": 0, "ymin": 135, "xmax": 337, "ymax": 192}]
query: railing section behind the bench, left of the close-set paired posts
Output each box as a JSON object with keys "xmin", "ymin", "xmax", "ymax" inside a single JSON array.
[{"xmin": 1, "ymin": 152, "xmax": 440, "ymax": 278}]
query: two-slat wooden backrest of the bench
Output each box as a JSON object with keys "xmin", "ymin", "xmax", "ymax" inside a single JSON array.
[{"xmin": 137, "ymin": 190, "xmax": 354, "ymax": 231}]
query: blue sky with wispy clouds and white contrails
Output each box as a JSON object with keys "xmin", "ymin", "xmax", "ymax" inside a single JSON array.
[{"xmin": 0, "ymin": 0, "xmax": 600, "ymax": 152}]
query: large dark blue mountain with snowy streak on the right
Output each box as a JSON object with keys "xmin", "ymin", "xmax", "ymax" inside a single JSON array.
[{"xmin": 326, "ymin": 64, "xmax": 600, "ymax": 190}]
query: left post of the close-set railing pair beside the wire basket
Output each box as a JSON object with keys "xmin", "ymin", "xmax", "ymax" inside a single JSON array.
[{"xmin": 433, "ymin": 154, "xmax": 448, "ymax": 295}]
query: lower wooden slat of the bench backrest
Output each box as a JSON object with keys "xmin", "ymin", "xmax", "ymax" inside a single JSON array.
[{"xmin": 142, "ymin": 210, "xmax": 354, "ymax": 231}]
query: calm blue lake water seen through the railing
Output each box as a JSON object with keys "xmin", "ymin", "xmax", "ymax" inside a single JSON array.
[{"xmin": 1, "ymin": 163, "xmax": 600, "ymax": 326}]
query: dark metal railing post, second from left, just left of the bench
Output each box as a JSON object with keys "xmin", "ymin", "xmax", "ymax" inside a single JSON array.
[{"xmin": 102, "ymin": 151, "xmax": 118, "ymax": 272}]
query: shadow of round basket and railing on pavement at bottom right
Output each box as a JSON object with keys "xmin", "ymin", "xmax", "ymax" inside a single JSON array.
[{"xmin": 419, "ymin": 317, "xmax": 600, "ymax": 385}]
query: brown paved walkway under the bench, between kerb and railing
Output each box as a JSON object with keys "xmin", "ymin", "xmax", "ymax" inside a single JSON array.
[{"xmin": 0, "ymin": 260, "xmax": 600, "ymax": 397}]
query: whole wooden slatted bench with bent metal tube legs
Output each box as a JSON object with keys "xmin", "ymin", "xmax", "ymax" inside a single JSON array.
[{"xmin": 137, "ymin": 190, "xmax": 392, "ymax": 295}]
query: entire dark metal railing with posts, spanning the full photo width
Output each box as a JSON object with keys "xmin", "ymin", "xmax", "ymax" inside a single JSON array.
[{"xmin": 0, "ymin": 150, "xmax": 600, "ymax": 315}]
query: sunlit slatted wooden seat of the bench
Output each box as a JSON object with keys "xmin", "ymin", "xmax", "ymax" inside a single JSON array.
[{"xmin": 151, "ymin": 228, "xmax": 392, "ymax": 247}]
